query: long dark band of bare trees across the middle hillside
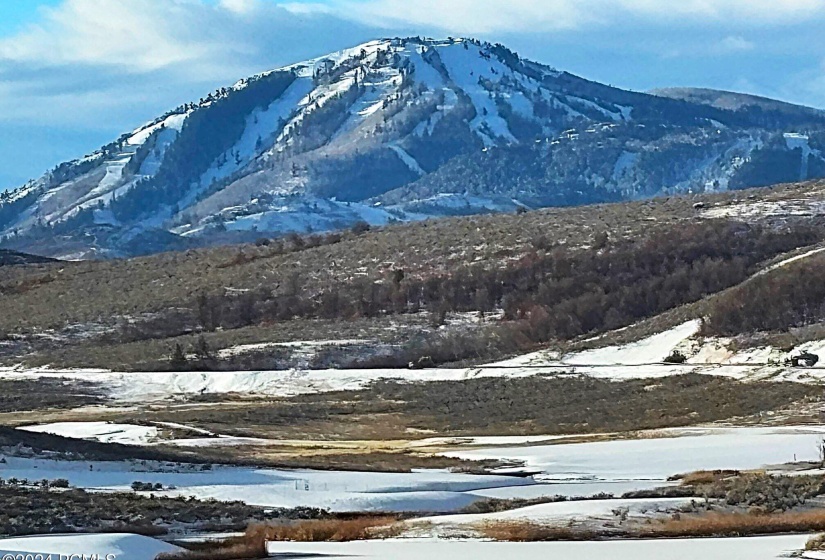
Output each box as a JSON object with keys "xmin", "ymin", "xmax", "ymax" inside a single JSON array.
[{"xmin": 192, "ymin": 221, "xmax": 825, "ymax": 342}]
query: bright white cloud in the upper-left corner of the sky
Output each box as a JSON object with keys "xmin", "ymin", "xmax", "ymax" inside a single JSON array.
[{"xmin": 0, "ymin": 0, "xmax": 370, "ymax": 74}]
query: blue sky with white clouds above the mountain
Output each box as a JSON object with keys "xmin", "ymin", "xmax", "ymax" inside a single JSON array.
[{"xmin": 0, "ymin": 0, "xmax": 825, "ymax": 189}]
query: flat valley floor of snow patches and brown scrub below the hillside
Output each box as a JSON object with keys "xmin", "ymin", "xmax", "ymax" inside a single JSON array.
[{"xmin": 0, "ymin": 321, "xmax": 825, "ymax": 560}]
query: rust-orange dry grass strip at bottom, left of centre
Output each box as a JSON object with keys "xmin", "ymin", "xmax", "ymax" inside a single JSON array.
[{"xmin": 244, "ymin": 516, "xmax": 401, "ymax": 542}]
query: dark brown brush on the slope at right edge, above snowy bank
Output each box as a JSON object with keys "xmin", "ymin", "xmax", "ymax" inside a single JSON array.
[{"xmin": 703, "ymin": 255, "xmax": 825, "ymax": 336}]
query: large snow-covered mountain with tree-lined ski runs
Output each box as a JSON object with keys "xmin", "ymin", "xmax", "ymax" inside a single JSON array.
[{"xmin": 0, "ymin": 38, "xmax": 825, "ymax": 258}]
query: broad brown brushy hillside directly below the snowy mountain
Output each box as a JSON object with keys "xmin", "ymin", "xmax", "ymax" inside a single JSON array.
[{"xmin": 0, "ymin": 183, "xmax": 825, "ymax": 369}]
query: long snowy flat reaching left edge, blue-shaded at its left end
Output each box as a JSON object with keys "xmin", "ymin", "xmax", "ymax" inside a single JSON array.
[{"xmin": 0, "ymin": 457, "xmax": 535, "ymax": 512}]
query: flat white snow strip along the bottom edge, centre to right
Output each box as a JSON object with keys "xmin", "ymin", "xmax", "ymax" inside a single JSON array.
[{"xmin": 269, "ymin": 535, "xmax": 809, "ymax": 560}]
